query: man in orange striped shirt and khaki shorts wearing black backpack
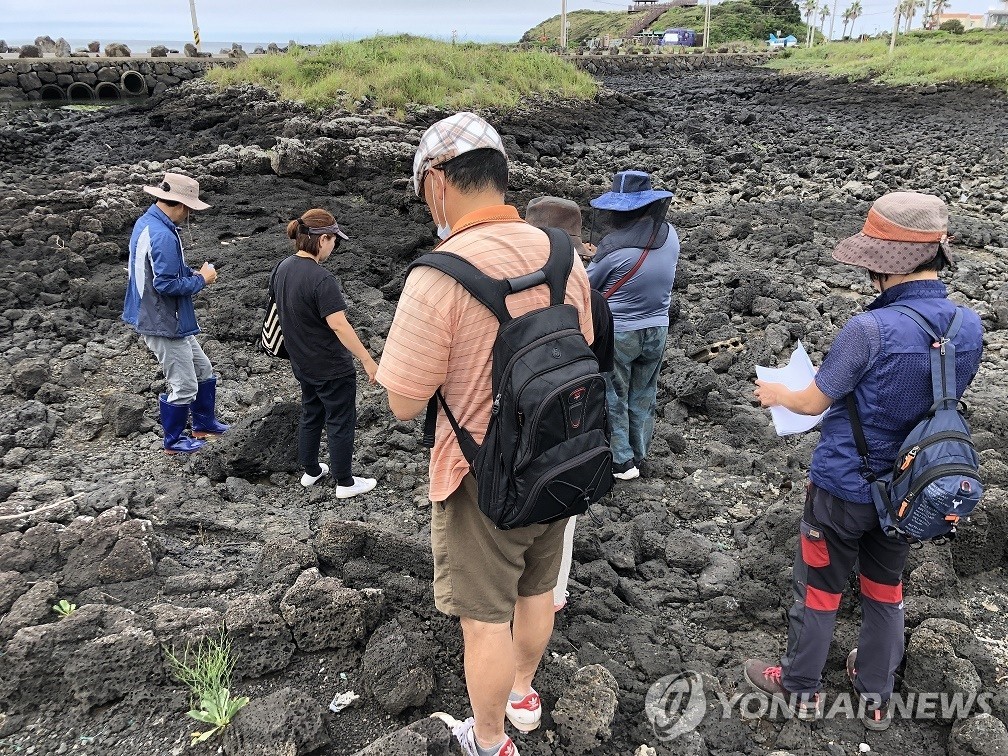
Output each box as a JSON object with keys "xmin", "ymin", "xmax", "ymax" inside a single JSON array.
[{"xmin": 377, "ymin": 113, "xmax": 596, "ymax": 756}]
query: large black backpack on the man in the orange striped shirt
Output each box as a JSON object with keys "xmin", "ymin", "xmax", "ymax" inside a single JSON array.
[{"xmin": 409, "ymin": 229, "xmax": 613, "ymax": 530}]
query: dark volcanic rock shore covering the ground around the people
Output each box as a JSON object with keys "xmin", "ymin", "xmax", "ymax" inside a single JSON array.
[{"xmin": 0, "ymin": 70, "xmax": 1008, "ymax": 756}]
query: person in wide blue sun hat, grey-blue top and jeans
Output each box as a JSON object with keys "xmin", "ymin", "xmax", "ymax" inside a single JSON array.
[{"xmin": 587, "ymin": 170, "xmax": 679, "ymax": 481}]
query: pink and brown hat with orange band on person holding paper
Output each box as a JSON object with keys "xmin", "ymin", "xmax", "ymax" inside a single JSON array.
[{"xmin": 833, "ymin": 192, "xmax": 953, "ymax": 274}]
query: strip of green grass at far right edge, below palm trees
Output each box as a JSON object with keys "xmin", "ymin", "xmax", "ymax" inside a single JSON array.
[{"xmin": 770, "ymin": 31, "xmax": 1008, "ymax": 91}]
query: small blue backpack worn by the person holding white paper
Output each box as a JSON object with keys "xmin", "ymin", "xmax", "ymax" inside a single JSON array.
[{"xmin": 847, "ymin": 304, "xmax": 983, "ymax": 543}]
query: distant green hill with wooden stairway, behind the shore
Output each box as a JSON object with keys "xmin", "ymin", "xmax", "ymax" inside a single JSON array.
[{"xmin": 521, "ymin": 0, "xmax": 806, "ymax": 46}]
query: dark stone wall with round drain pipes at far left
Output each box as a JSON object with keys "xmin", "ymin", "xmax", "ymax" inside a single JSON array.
[{"xmin": 0, "ymin": 58, "xmax": 229, "ymax": 103}]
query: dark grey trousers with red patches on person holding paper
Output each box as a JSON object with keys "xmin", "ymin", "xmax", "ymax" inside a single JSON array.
[{"xmin": 780, "ymin": 484, "xmax": 909, "ymax": 702}]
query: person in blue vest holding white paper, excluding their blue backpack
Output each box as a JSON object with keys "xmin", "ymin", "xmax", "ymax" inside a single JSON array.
[{"xmin": 743, "ymin": 192, "xmax": 983, "ymax": 731}]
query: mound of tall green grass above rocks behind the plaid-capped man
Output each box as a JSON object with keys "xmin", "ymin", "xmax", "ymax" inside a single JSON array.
[{"xmin": 208, "ymin": 35, "xmax": 598, "ymax": 112}]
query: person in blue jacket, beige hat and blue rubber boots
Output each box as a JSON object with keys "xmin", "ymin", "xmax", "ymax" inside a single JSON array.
[{"xmin": 122, "ymin": 173, "xmax": 228, "ymax": 454}]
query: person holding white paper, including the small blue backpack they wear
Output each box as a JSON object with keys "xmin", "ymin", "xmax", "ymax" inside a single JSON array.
[{"xmin": 744, "ymin": 192, "xmax": 983, "ymax": 730}]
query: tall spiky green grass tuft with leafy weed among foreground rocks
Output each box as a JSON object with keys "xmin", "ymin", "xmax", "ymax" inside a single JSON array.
[{"xmin": 164, "ymin": 628, "xmax": 249, "ymax": 745}]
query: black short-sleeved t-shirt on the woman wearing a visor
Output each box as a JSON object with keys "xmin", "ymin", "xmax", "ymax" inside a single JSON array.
[{"xmin": 273, "ymin": 255, "xmax": 355, "ymax": 381}]
